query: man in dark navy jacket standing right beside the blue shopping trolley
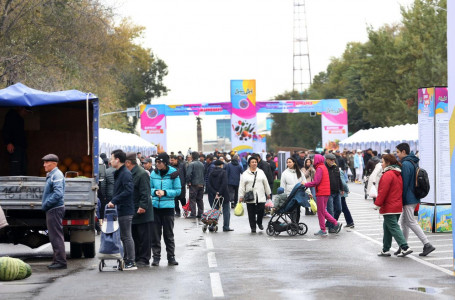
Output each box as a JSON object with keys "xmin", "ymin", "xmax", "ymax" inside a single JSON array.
[{"xmin": 108, "ymin": 149, "xmax": 137, "ymax": 271}]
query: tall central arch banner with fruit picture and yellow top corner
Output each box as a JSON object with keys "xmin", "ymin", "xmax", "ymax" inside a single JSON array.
[{"xmin": 231, "ymin": 80, "xmax": 257, "ymax": 154}]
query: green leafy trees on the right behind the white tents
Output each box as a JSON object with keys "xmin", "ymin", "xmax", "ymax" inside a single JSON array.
[{"xmin": 269, "ymin": 0, "xmax": 447, "ymax": 148}]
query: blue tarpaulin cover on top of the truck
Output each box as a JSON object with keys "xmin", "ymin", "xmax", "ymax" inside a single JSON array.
[{"xmin": 0, "ymin": 83, "xmax": 98, "ymax": 107}]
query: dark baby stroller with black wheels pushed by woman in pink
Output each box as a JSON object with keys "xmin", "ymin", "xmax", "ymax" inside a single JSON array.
[{"xmin": 266, "ymin": 183, "xmax": 310, "ymax": 236}]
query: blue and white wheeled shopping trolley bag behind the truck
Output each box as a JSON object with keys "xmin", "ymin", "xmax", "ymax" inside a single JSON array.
[{"xmin": 98, "ymin": 205, "xmax": 125, "ymax": 272}]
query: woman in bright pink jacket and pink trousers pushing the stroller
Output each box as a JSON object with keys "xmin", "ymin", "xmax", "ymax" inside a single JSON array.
[{"xmin": 304, "ymin": 154, "xmax": 342, "ymax": 236}]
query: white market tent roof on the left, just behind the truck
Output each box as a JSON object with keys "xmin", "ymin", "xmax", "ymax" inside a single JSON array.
[{"xmin": 100, "ymin": 128, "xmax": 157, "ymax": 156}]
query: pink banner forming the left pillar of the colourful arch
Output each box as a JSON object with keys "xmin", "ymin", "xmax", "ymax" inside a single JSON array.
[{"xmin": 140, "ymin": 104, "xmax": 167, "ymax": 153}]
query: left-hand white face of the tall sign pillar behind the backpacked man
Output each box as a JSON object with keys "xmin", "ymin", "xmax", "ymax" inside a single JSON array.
[{"xmin": 417, "ymin": 88, "xmax": 435, "ymax": 204}]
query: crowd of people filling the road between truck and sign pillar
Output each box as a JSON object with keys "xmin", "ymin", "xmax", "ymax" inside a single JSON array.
[{"xmin": 89, "ymin": 144, "xmax": 434, "ymax": 270}]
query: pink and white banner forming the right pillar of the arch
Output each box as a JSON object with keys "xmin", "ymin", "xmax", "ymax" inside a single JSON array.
[{"xmin": 321, "ymin": 99, "xmax": 348, "ymax": 150}]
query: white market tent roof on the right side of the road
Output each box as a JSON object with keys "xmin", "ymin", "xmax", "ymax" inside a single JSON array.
[{"xmin": 340, "ymin": 124, "xmax": 419, "ymax": 153}]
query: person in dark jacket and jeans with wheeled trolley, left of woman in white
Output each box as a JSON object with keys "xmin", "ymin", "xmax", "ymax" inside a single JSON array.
[{"xmin": 207, "ymin": 159, "xmax": 234, "ymax": 232}]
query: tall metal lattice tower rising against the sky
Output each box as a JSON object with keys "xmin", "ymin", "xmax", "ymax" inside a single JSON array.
[{"xmin": 292, "ymin": 0, "xmax": 311, "ymax": 92}]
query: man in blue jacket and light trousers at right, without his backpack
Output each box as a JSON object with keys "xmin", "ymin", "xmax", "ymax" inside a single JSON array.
[{"xmin": 394, "ymin": 143, "xmax": 436, "ymax": 256}]
